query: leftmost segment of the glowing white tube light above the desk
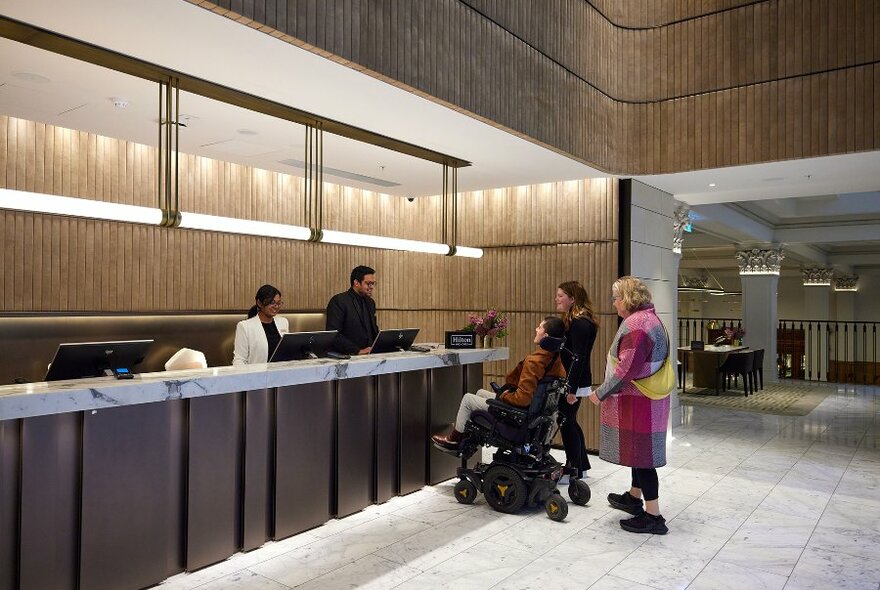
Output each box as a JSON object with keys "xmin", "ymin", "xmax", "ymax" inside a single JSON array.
[{"xmin": 0, "ymin": 188, "xmax": 162, "ymax": 225}]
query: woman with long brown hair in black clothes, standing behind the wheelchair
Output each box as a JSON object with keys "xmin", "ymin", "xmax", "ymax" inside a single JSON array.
[{"xmin": 555, "ymin": 281, "xmax": 598, "ymax": 478}]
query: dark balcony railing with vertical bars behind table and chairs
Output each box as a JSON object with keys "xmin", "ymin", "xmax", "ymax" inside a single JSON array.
[{"xmin": 678, "ymin": 317, "xmax": 880, "ymax": 385}]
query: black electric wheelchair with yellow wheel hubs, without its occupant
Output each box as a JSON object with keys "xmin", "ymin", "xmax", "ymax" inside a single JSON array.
[{"xmin": 434, "ymin": 337, "xmax": 590, "ymax": 521}]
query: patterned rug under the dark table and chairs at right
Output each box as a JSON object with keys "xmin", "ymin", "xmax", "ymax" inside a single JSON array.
[{"xmin": 679, "ymin": 381, "xmax": 837, "ymax": 416}]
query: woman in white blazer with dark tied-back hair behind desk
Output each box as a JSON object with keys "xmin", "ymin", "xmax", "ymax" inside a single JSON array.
[{"xmin": 232, "ymin": 285, "xmax": 290, "ymax": 366}]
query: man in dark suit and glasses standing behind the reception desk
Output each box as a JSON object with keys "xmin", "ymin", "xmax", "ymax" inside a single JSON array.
[{"xmin": 327, "ymin": 266, "xmax": 379, "ymax": 354}]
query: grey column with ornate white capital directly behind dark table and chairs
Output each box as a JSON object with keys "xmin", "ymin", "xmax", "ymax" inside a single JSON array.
[{"xmin": 736, "ymin": 248, "xmax": 785, "ymax": 383}]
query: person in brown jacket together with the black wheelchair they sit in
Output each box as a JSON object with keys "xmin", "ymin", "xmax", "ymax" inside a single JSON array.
[{"xmin": 432, "ymin": 316, "xmax": 590, "ymax": 520}]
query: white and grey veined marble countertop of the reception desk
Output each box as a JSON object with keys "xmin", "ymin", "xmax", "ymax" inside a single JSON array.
[{"xmin": 0, "ymin": 348, "xmax": 509, "ymax": 420}]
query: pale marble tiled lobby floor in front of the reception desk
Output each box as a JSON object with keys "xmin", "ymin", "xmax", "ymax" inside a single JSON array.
[{"xmin": 158, "ymin": 385, "xmax": 880, "ymax": 590}]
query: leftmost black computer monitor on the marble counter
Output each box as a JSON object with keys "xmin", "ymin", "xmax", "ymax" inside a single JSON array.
[{"xmin": 45, "ymin": 340, "xmax": 153, "ymax": 381}]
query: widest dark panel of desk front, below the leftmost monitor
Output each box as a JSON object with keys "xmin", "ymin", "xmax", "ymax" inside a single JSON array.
[{"xmin": 80, "ymin": 402, "xmax": 185, "ymax": 590}]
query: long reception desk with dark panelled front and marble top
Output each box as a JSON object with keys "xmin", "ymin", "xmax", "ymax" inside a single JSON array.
[{"xmin": 0, "ymin": 348, "xmax": 508, "ymax": 590}]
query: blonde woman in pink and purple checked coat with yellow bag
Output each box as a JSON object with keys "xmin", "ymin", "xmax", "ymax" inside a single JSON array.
[{"xmin": 590, "ymin": 277, "xmax": 674, "ymax": 535}]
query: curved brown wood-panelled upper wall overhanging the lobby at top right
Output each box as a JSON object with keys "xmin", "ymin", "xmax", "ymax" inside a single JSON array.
[{"xmin": 189, "ymin": 0, "xmax": 880, "ymax": 175}]
